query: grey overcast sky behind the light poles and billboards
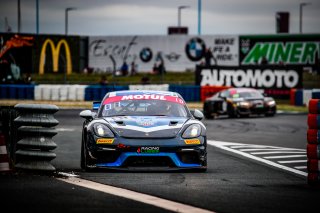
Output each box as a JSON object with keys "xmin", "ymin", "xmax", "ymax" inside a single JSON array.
[{"xmin": 0, "ymin": 0, "xmax": 320, "ymax": 35}]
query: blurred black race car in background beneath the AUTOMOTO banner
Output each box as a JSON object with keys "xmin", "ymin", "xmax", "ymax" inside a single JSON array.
[{"xmin": 203, "ymin": 88, "xmax": 277, "ymax": 119}]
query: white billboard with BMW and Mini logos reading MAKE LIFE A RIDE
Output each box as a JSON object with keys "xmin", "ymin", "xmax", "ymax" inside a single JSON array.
[{"xmin": 89, "ymin": 35, "xmax": 239, "ymax": 72}]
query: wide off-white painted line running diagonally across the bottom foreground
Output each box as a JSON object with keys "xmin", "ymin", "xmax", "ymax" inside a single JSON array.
[{"xmin": 57, "ymin": 177, "xmax": 214, "ymax": 213}]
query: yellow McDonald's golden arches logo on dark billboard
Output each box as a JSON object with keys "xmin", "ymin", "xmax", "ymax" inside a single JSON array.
[{"xmin": 39, "ymin": 38, "xmax": 72, "ymax": 75}]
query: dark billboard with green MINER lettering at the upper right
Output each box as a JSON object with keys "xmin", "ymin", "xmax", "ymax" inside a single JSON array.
[{"xmin": 239, "ymin": 34, "xmax": 320, "ymax": 66}]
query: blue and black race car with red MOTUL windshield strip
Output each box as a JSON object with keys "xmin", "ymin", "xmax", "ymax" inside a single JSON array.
[{"xmin": 80, "ymin": 90, "xmax": 207, "ymax": 171}]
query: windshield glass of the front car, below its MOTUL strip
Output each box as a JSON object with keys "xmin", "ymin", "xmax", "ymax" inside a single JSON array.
[{"xmin": 100, "ymin": 100, "xmax": 188, "ymax": 117}]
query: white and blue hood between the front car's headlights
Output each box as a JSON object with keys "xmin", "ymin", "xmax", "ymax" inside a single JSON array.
[{"xmin": 104, "ymin": 116, "xmax": 188, "ymax": 138}]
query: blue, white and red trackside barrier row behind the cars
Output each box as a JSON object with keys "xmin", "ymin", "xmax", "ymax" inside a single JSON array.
[{"xmin": 0, "ymin": 84, "xmax": 320, "ymax": 106}]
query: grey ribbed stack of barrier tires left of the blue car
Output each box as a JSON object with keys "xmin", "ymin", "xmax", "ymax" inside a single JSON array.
[{"xmin": 14, "ymin": 104, "xmax": 59, "ymax": 172}]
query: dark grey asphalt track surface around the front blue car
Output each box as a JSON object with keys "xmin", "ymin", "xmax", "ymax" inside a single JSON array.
[{"xmin": 0, "ymin": 110, "xmax": 320, "ymax": 212}]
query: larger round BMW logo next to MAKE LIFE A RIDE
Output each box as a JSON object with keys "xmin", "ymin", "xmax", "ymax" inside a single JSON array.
[{"xmin": 185, "ymin": 37, "xmax": 206, "ymax": 61}]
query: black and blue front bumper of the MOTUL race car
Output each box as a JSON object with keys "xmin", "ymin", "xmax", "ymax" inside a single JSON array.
[{"xmin": 88, "ymin": 134, "xmax": 207, "ymax": 169}]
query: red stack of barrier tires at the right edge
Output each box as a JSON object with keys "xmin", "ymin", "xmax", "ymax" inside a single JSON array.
[{"xmin": 307, "ymin": 99, "xmax": 320, "ymax": 185}]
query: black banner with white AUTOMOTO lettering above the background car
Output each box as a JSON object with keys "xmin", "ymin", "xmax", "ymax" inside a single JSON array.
[{"xmin": 196, "ymin": 66, "xmax": 302, "ymax": 89}]
